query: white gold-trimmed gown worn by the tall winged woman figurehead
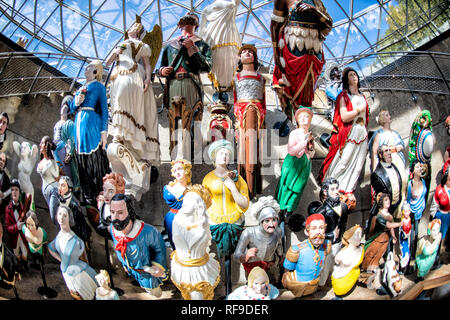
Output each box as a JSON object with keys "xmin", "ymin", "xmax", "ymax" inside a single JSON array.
[{"xmin": 108, "ymin": 39, "xmax": 160, "ymax": 165}]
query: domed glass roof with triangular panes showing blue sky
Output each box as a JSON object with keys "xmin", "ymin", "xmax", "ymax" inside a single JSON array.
[{"xmin": 0, "ymin": 0, "xmax": 450, "ymax": 76}]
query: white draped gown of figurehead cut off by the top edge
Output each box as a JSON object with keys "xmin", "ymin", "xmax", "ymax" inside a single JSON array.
[{"xmin": 199, "ymin": 0, "xmax": 241, "ymax": 87}]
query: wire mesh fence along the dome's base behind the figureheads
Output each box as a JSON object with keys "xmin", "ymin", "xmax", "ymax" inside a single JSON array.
[{"xmin": 0, "ymin": 51, "xmax": 450, "ymax": 97}]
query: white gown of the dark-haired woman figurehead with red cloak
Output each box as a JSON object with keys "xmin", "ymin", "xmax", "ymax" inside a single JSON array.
[{"xmin": 324, "ymin": 95, "xmax": 368, "ymax": 193}]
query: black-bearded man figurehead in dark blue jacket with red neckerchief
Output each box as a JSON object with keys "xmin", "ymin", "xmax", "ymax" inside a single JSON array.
[{"xmin": 109, "ymin": 193, "xmax": 168, "ymax": 298}]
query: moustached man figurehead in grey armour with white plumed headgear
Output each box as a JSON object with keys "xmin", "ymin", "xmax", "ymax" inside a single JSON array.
[{"xmin": 233, "ymin": 196, "xmax": 283, "ymax": 274}]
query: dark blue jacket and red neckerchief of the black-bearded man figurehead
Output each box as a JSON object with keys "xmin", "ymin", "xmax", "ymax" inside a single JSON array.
[{"xmin": 110, "ymin": 220, "xmax": 167, "ymax": 289}]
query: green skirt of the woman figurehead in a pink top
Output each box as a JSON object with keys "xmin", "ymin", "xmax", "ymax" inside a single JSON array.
[{"xmin": 275, "ymin": 153, "xmax": 311, "ymax": 212}]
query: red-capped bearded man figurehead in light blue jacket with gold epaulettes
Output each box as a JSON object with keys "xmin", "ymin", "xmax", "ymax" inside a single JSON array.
[{"xmin": 282, "ymin": 213, "xmax": 331, "ymax": 297}]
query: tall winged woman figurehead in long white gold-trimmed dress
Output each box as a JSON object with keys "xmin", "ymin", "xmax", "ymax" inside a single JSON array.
[{"xmin": 106, "ymin": 16, "xmax": 160, "ymax": 166}]
